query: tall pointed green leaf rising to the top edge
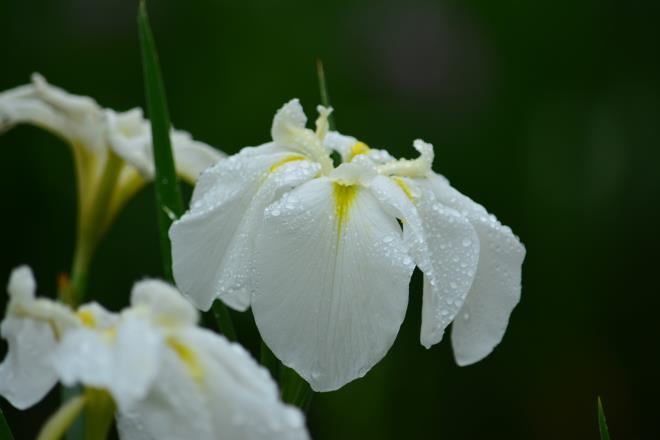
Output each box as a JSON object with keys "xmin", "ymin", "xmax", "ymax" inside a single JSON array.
[{"xmin": 138, "ymin": 0, "xmax": 183, "ymax": 280}]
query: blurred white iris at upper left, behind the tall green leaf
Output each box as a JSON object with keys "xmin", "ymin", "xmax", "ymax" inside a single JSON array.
[{"xmin": 0, "ymin": 74, "xmax": 224, "ymax": 264}]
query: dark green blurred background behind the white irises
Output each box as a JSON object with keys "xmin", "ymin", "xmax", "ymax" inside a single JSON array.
[{"xmin": 0, "ymin": 0, "xmax": 660, "ymax": 439}]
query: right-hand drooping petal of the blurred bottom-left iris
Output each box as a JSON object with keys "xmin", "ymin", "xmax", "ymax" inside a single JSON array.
[{"xmin": 176, "ymin": 328, "xmax": 308, "ymax": 440}]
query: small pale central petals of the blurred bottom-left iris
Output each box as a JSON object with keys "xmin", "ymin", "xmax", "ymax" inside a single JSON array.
[{"xmin": 52, "ymin": 311, "xmax": 164, "ymax": 410}]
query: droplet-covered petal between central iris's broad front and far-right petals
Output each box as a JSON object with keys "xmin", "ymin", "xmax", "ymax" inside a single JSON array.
[{"xmin": 402, "ymin": 177, "xmax": 479, "ymax": 348}]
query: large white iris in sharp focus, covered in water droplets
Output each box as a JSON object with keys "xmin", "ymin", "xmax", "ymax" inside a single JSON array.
[{"xmin": 170, "ymin": 100, "xmax": 525, "ymax": 391}]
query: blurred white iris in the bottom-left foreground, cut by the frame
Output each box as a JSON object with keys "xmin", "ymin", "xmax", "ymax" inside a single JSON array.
[{"xmin": 0, "ymin": 267, "xmax": 308, "ymax": 440}]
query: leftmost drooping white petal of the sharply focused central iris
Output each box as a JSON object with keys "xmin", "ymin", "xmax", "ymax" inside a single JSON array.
[{"xmin": 170, "ymin": 150, "xmax": 319, "ymax": 310}]
